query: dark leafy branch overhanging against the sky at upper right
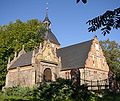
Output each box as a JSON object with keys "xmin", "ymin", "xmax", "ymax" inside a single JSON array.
[{"xmin": 87, "ymin": 7, "xmax": 120, "ymax": 35}]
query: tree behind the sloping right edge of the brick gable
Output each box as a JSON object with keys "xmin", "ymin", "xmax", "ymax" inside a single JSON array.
[{"xmin": 100, "ymin": 39, "xmax": 120, "ymax": 76}]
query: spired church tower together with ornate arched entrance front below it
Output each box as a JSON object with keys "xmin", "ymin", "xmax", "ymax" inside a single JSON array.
[{"xmin": 36, "ymin": 3, "xmax": 61, "ymax": 82}]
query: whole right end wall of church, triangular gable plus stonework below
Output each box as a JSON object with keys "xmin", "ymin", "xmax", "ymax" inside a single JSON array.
[{"xmin": 83, "ymin": 38, "xmax": 109, "ymax": 81}]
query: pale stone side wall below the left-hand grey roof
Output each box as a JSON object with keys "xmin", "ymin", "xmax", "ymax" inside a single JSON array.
[{"xmin": 6, "ymin": 66, "xmax": 35, "ymax": 87}]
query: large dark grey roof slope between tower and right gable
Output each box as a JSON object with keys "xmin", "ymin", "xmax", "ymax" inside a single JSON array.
[{"xmin": 57, "ymin": 40, "xmax": 92, "ymax": 70}]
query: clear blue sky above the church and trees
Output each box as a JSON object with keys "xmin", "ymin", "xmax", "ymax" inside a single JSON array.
[{"xmin": 0, "ymin": 0, "xmax": 120, "ymax": 47}]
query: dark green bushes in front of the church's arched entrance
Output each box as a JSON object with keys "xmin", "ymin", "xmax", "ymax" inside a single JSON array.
[{"xmin": 30, "ymin": 78, "xmax": 96, "ymax": 101}]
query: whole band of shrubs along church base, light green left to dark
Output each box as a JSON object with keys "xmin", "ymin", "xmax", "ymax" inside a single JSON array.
[{"xmin": 0, "ymin": 79, "xmax": 97, "ymax": 101}]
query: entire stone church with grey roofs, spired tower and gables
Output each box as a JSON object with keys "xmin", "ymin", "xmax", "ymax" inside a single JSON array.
[{"xmin": 5, "ymin": 11, "xmax": 109, "ymax": 87}]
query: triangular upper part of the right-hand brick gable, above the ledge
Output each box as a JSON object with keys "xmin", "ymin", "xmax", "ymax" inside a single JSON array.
[{"xmin": 85, "ymin": 38, "xmax": 109, "ymax": 71}]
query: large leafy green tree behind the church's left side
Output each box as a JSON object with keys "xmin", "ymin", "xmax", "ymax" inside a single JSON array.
[{"xmin": 0, "ymin": 19, "xmax": 45, "ymax": 89}]
